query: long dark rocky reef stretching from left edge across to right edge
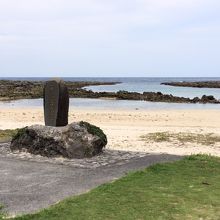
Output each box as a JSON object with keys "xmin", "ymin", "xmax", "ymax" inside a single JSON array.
[{"xmin": 0, "ymin": 81, "xmax": 220, "ymax": 104}]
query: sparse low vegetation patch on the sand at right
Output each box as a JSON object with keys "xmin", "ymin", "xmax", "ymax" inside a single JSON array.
[{"xmin": 141, "ymin": 132, "xmax": 220, "ymax": 145}]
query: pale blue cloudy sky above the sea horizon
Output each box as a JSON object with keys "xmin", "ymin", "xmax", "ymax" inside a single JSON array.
[{"xmin": 0, "ymin": 0, "xmax": 220, "ymax": 77}]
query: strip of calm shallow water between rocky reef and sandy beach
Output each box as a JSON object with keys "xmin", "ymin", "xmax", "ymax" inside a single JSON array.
[{"xmin": 0, "ymin": 98, "xmax": 220, "ymax": 111}]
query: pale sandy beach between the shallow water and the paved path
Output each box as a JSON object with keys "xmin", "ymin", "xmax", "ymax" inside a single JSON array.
[{"xmin": 0, "ymin": 107, "xmax": 220, "ymax": 156}]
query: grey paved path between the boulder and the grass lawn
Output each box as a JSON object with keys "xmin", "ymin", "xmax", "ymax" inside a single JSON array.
[{"xmin": 0, "ymin": 150, "xmax": 181, "ymax": 215}]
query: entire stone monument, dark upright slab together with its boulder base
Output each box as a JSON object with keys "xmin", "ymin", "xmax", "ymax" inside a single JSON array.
[{"xmin": 10, "ymin": 80, "xmax": 107, "ymax": 158}]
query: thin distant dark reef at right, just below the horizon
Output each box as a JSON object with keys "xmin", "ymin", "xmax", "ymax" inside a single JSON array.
[{"xmin": 161, "ymin": 81, "xmax": 220, "ymax": 88}]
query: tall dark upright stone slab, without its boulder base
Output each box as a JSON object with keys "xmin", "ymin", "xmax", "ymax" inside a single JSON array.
[{"xmin": 44, "ymin": 80, "xmax": 69, "ymax": 127}]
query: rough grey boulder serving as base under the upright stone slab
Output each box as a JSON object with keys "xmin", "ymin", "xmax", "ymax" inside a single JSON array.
[{"xmin": 10, "ymin": 121, "xmax": 107, "ymax": 158}]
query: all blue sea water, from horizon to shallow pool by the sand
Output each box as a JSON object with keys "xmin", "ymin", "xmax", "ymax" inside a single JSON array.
[{"xmin": 0, "ymin": 77, "xmax": 220, "ymax": 110}]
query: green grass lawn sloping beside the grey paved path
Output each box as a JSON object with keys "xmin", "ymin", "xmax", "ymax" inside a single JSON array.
[{"xmin": 1, "ymin": 155, "xmax": 220, "ymax": 220}]
